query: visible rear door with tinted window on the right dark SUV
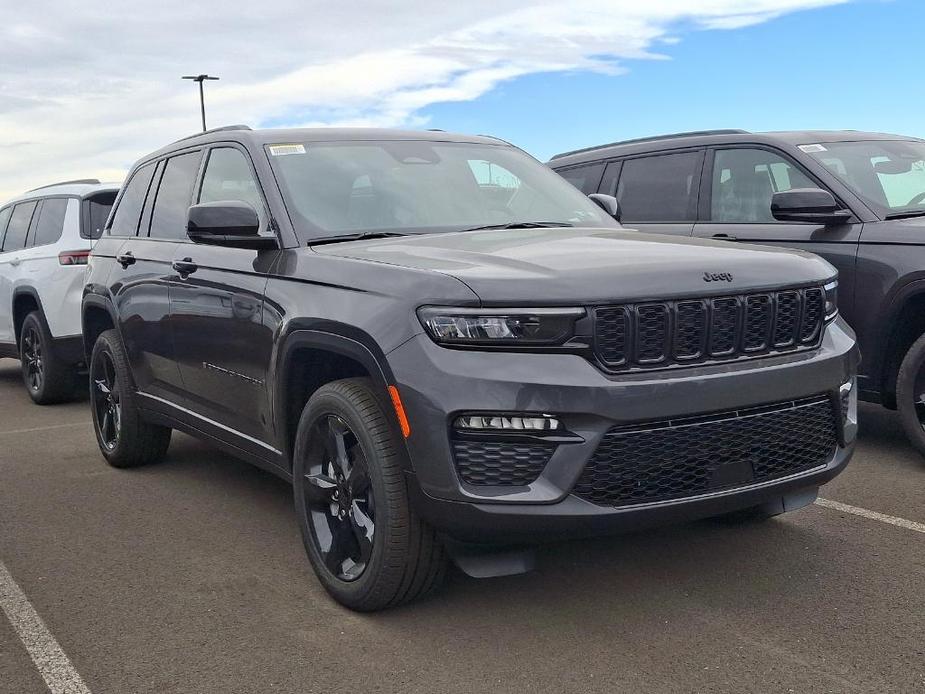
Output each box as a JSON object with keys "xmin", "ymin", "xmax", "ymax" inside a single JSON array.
[{"xmin": 599, "ymin": 149, "xmax": 703, "ymax": 236}]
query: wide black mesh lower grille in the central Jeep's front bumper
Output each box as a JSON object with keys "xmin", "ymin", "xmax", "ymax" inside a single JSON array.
[{"xmin": 572, "ymin": 396, "xmax": 838, "ymax": 506}]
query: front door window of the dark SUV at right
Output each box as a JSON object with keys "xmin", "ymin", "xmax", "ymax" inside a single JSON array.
[{"xmin": 710, "ymin": 149, "xmax": 818, "ymax": 224}]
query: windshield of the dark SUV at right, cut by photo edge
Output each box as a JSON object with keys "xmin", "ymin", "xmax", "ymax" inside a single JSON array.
[{"xmin": 800, "ymin": 140, "xmax": 925, "ymax": 217}]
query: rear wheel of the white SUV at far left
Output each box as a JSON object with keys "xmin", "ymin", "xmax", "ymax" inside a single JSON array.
[{"xmin": 19, "ymin": 311, "xmax": 75, "ymax": 405}]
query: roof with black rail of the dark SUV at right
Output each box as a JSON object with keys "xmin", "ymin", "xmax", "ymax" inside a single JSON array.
[{"xmin": 550, "ymin": 129, "xmax": 919, "ymax": 168}]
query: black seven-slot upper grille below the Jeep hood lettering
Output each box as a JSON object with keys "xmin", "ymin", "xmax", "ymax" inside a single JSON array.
[{"xmin": 593, "ymin": 287, "xmax": 825, "ymax": 370}]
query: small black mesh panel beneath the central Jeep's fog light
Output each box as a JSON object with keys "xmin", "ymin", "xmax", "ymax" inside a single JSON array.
[{"xmin": 453, "ymin": 439, "xmax": 556, "ymax": 487}]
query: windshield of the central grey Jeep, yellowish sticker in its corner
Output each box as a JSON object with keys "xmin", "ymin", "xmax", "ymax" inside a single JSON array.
[{"xmin": 267, "ymin": 140, "xmax": 617, "ymax": 239}]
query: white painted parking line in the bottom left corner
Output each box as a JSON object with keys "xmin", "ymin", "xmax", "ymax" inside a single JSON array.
[{"xmin": 0, "ymin": 562, "xmax": 90, "ymax": 694}]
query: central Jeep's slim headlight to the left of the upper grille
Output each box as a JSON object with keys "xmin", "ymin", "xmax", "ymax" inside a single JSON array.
[{"xmin": 418, "ymin": 306, "xmax": 585, "ymax": 346}]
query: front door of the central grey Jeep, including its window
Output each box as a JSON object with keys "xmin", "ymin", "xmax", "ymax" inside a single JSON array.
[{"xmin": 170, "ymin": 144, "xmax": 279, "ymax": 446}]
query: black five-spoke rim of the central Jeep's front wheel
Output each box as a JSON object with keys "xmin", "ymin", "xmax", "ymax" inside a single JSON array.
[{"xmin": 301, "ymin": 414, "xmax": 376, "ymax": 581}]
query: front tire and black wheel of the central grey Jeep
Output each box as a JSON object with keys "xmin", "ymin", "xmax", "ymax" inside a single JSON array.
[{"xmin": 293, "ymin": 378, "xmax": 446, "ymax": 612}]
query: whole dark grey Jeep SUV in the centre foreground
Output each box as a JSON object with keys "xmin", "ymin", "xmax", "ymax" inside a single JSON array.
[{"xmin": 83, "ymin": 127, "xmax": 857, "ymax": 610}]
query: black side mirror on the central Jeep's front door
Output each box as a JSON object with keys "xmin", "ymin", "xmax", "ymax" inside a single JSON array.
[{"xmin": 186, "ymin": 200, "xmax": 279, "ymax": 251}]
